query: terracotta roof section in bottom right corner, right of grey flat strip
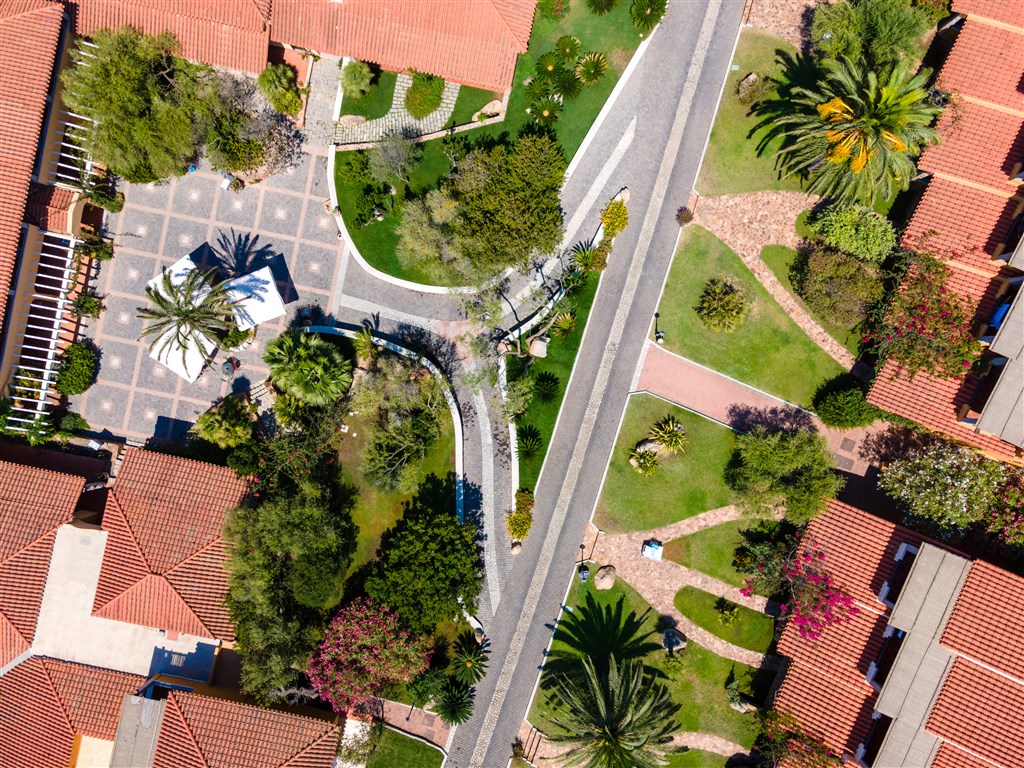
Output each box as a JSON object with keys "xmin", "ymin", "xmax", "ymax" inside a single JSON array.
[{"xmin": 925, "ymin": 658, "xmax": 1024, "ymax": 768}]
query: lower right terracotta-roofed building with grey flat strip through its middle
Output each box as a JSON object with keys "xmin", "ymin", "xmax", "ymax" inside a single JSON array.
[{"xmin": 774, "ymin": 502, "xmax": 1024, "ymax": 768}]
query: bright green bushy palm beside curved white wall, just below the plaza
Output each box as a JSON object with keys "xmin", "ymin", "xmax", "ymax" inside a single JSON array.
[{"xmin": 263, "ymin": 329, "xmax": 352, "ymax": 406}]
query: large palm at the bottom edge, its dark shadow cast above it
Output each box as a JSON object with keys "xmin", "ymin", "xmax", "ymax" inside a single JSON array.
[{"xmin": 548, "ymin": 656, "xmax": 680, "ymax": 768}]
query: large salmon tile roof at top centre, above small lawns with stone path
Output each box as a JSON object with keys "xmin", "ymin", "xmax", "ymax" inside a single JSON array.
[{"xmin": 270, "ymin": 0, "xmax": 536, "ymax": 91}]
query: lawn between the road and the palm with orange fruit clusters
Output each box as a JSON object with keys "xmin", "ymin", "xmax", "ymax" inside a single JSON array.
[{"xmin": 696, "ymin": 29, "xmax": 800, "ymax": 195}]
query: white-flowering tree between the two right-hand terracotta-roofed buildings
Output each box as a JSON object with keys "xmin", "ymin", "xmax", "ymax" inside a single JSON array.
[{"xmin": 879, "ymin": 441, "xmax": 1005, "ymax": 539}]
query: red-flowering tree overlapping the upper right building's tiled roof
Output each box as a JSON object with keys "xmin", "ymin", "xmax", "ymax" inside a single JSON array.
[{"xmin": 865, "ymin": 255, "xmax": 981, "ymax": 379}]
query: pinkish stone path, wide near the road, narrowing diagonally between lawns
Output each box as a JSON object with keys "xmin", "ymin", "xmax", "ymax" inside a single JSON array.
[{"xmin": 693, "ymin": 190, "xmax": 856, "ymax": 371}]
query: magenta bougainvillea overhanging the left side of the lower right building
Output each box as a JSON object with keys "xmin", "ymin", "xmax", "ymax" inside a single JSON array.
[{"xmin": 740, "ymin": 536, "xmax": 859, "ymax": 640}]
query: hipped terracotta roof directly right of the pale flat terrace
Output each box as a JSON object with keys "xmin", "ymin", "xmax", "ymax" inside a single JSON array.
[{"xmin": 93, "ymin": 449, "xmax": 246, "ymax": 641}]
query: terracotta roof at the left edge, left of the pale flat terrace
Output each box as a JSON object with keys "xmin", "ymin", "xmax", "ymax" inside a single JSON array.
[{"xmin": 0, "ymin": 462, "xmax": 85, "ymax": 667}]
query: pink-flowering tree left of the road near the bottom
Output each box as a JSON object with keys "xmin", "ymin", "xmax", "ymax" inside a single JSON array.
[{"xmin": 307, "ymin": 599, "xmax": 431, "ymax": 713}]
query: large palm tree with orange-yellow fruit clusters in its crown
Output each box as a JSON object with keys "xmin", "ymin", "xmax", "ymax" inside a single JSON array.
[{"xmin": 755, "ymin": 58, "xmax": 941, "ymax": 204}]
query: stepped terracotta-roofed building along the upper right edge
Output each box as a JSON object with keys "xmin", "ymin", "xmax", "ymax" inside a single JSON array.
[{"xmin": 868, "ymin": 0, "xmax": 1024, "ymax": 463}]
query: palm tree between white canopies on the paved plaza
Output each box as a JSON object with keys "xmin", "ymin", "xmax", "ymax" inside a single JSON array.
[{"xmin": 135, "ymin": 269, "xmax": 233, "ymax": 364}]
